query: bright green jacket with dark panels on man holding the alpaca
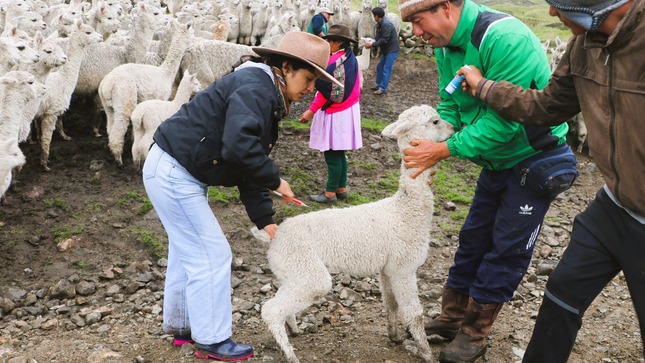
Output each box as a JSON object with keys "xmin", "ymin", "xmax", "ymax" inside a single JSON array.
[{"xmin": 435, "ymin": 0, "xmax": 568, "ymax": 170}]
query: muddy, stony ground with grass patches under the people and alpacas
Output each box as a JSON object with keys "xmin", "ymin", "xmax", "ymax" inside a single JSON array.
[{"xmin": 0, "ymin": 57, "xmax": 643, "ymax": 363}]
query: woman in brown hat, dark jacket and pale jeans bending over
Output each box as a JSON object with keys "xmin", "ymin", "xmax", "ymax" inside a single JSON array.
[{"xmin": 143, "ymin": 32, "xmax": 337, "ymax": 360}]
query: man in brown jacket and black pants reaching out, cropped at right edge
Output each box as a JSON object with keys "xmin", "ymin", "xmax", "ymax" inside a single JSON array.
[{"xmin": 460, "ymin": 0, "xmax": 645, "ymax": 363}]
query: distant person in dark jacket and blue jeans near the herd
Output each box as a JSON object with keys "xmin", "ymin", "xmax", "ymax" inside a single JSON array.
[{"xmin": 365, "ymin": 7, "xmax": 401, "ymax": 95}]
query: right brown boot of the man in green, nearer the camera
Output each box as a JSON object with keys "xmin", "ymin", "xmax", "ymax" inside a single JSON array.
[{"xmin": 439, "ymin": 298, "xmax": 504, "ymax": 363}]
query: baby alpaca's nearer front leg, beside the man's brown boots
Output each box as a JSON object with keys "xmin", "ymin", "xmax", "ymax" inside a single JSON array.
[{"xmin": 391, "ymin": 271, "xmax": 434, "ymax": 362}]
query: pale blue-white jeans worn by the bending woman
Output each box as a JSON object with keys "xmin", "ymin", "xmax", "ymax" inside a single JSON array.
[{"xmin": 143, "ymin": 144, "xmax": 232, "ymax": 344}]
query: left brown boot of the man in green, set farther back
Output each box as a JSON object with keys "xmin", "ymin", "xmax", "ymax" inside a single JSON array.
[{"xmin": 425, "ymin": 285, "xmax": 468, "ymax": 340}]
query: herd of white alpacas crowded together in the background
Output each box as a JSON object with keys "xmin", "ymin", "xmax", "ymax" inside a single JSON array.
[{"xmin": 0, "ymin": 0, "xmax": 401, "ymax": 181}]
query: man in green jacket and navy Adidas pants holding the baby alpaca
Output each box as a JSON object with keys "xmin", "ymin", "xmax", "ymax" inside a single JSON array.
[{"xmin": 399, "ymin": 0, "xmax": 577, "ymax": 362}]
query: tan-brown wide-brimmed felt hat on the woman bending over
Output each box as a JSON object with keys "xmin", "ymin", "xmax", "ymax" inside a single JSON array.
[{"xmin": 251, "ymin": 31, "xmax": 343, "ymax": 87}]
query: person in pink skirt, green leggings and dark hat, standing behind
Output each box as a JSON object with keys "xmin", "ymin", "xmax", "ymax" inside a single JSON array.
[{"xmin": 300, "ymin": 25, "xmax": 363, "ymax": 203}]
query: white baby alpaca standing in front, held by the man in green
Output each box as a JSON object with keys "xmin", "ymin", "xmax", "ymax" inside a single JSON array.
[{"xmin": 252, "ymin": 105, "xmax": 454, "ymax": 363}]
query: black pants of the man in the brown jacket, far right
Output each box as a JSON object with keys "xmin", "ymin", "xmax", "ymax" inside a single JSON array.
[{"xmin": 522, "ymin": 189, "xmax": 645, "ymax": 363}]
